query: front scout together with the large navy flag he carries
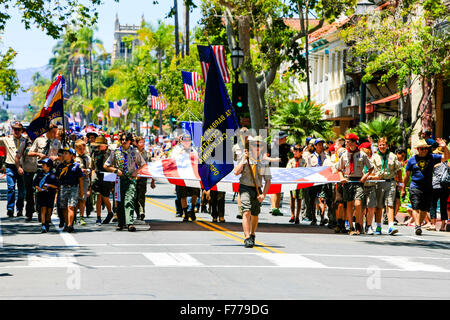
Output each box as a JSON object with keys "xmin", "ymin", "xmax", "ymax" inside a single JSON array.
[{"xmin": 198, "ymin": 46, "xmax": 270, "ymax": 248}]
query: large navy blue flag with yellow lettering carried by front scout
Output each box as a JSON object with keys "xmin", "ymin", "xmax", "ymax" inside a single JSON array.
[{"xmin": 198, "ymin": 47, "xmax": 239, "ymax": 191}]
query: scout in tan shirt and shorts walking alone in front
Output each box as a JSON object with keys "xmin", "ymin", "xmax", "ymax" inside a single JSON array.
[{"xmin": 234, "ymin": 136, "xmax": 271, "ymax": 248}]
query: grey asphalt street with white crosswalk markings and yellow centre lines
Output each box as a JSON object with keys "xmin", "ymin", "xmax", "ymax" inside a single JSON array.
[{"xmin": 0, "ymin": 183, "xmax": 450, "ymax": 300}]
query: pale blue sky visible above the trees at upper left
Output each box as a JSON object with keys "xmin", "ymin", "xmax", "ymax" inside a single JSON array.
[{"xmin": 0, "ymin": 0, "xmax": 201, "ymax": 69}]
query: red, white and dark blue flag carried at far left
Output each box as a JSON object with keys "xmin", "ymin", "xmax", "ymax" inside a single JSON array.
[{"xmin": 26, "ymin": 74, "xmax": 65, "ymax": 140}]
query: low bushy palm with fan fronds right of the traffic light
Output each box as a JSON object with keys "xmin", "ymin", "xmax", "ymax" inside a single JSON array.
[{"xmin": 272, "ymin": 99, "xmax": 332, "ymax": 143}]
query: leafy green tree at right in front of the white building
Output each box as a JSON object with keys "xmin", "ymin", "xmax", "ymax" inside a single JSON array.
[{"xmin": 342, "ymin": 0, "xmax": 450, "ymax": 147}]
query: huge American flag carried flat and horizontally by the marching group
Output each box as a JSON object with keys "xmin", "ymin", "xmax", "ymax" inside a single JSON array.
[{"xmin": 139, "ymin": 154, "xmax": 339, "ymax": 194}]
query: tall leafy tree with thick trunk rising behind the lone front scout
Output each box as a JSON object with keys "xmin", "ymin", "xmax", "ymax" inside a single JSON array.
[{"xmin": 204, "ymin": 0, "xmax": 356, "ymax": 129}]
